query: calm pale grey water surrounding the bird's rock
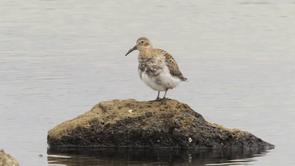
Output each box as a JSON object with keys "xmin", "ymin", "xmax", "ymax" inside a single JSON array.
[{"xmin": 0, "ymin": 0, "xmax": 295, "ymax": 166}]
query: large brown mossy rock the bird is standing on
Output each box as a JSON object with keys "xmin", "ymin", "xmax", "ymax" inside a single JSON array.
[{"xmin": 47, "ymin": 99, "xmax": 274, "ymax": 151}]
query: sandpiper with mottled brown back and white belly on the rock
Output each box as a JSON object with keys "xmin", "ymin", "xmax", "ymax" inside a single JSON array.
[{"xmin": 125, "ymin": 37, "xmax": 187, "ymax": 100}]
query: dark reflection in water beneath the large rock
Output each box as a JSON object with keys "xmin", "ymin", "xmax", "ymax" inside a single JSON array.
[{"xmin": 48, "ymin": 148, "xmax": 266, "ymax": 166}]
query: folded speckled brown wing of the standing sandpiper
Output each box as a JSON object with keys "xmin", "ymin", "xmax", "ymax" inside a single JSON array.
[{"xmin": 157, "ymin": 50, "xmax": 187, "ymax": 81}]
